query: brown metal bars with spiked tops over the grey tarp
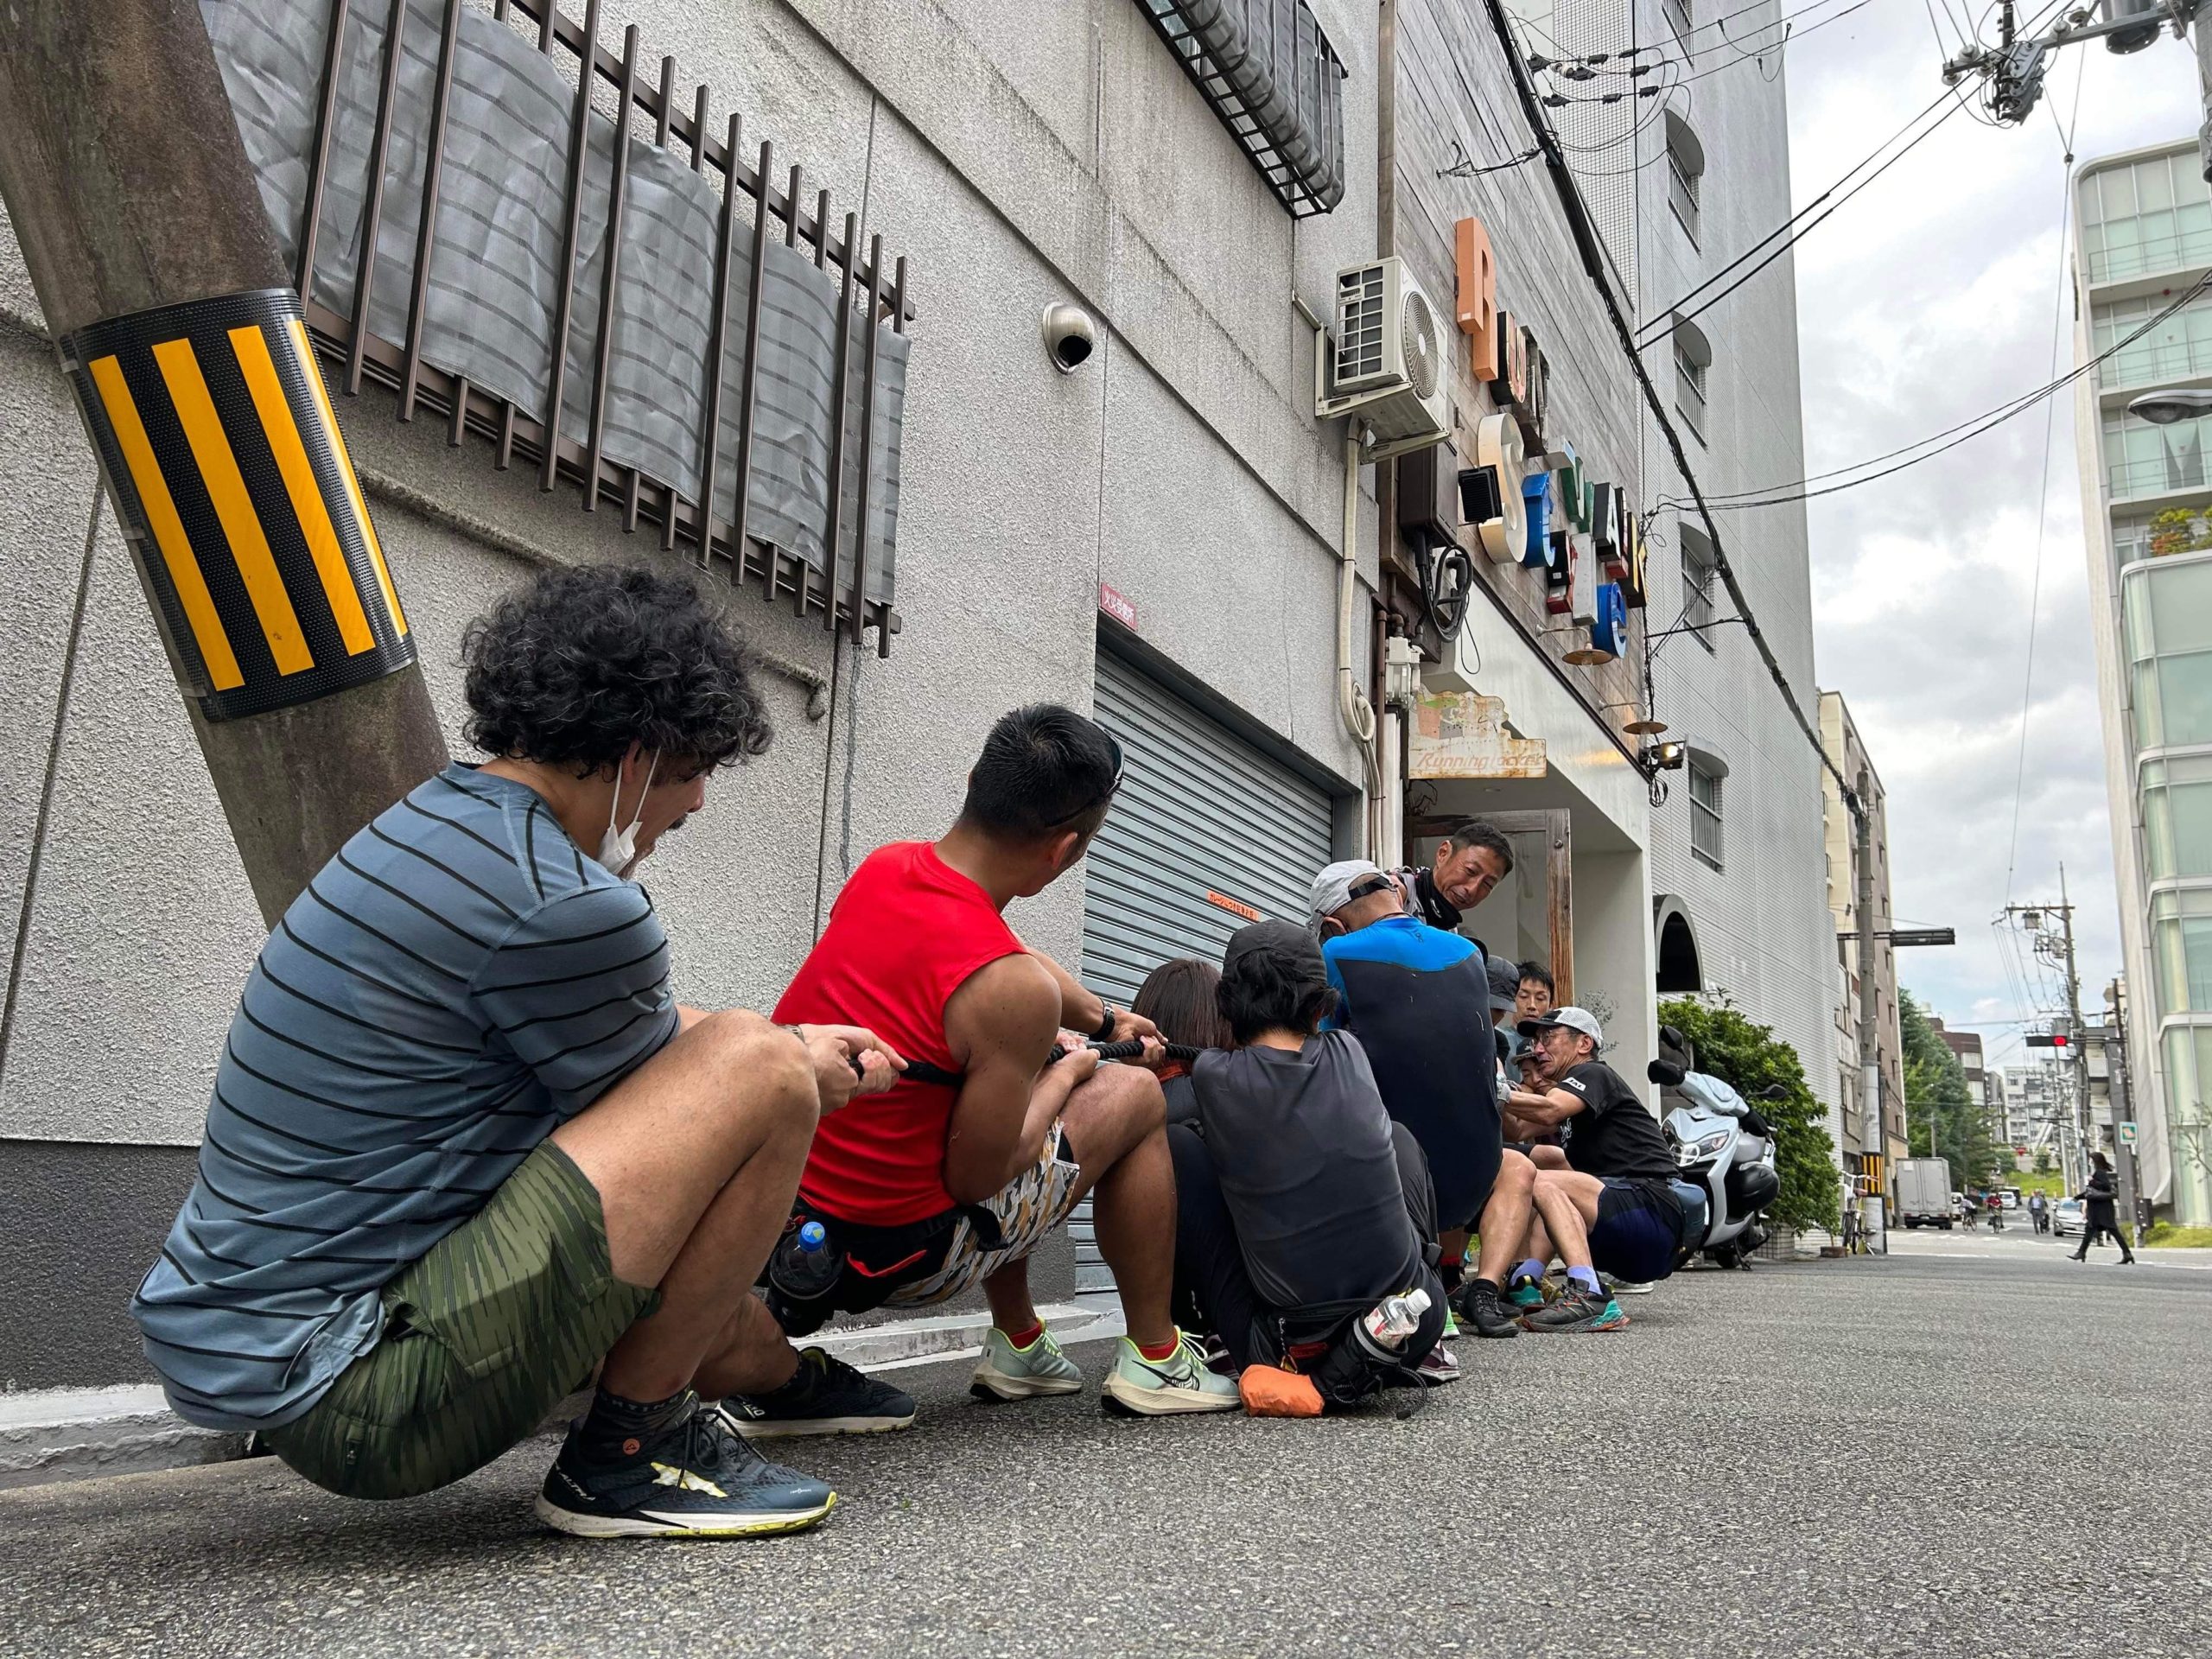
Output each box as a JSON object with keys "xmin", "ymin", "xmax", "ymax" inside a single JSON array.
[{"xmin": 281, "ymin": 0, "xmax": 913, "ymax": 655}]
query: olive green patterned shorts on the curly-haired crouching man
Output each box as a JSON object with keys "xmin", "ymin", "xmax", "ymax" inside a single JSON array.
[{"xmin": 265, "ymin": 1141, "xmax": 659, "ymax": 1497}]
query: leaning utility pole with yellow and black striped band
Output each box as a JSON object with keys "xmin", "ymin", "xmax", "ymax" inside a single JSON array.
[{"xmin": 0, "ymin": 0, "xmax": 447, "ymax": 925}]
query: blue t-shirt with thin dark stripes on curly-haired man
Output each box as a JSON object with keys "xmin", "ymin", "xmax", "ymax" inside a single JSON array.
[{"xmin": 133, "ymin": 766, "xmax": 677, "ymax": 1429}]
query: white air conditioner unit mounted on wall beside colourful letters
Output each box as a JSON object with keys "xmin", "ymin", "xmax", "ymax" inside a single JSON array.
[{"xmin": 1319, "ymin": 259, "xmax": 1451, "ymax": 460}]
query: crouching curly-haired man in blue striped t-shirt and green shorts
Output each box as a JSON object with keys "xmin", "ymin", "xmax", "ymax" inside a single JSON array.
[{"xmin": 133, "ymin": 569, "xmax": 902, "ymax": 1537}]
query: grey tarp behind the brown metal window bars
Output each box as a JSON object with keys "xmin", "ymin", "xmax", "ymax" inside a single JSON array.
[{"xmin": 201, "ymin": 0, "xmax": 907, "ymax": 601}]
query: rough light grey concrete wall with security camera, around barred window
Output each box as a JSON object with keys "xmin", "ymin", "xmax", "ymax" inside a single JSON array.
[{"xmin": 0, "ymin": 0, "xmax": 1376, "ymax": 1385}]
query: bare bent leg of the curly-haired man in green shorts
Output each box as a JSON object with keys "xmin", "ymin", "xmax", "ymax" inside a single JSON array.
[{"xmin": 553, "ymin": 1013, "xmax": 821, "ymax": 1400}]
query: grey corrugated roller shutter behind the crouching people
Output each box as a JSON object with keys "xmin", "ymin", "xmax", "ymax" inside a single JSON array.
[{"xmin": 1068, "ymin": 652, "xmax": 1332, "ymax": 1289}]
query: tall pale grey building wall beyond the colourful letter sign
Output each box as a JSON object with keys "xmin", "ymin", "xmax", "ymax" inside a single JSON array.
[{"xmin": 1635, "ymin": 0, "xmax": 1838, "ymax": 1110}]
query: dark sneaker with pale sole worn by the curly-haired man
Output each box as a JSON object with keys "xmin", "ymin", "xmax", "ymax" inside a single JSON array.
[{"xmin": 537, "ymin": 1400, "xmax": 836, "ymax": 1537}]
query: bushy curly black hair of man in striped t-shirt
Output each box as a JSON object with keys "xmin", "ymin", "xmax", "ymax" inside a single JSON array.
[{"xmin": 460, "ymin": 564, "xmax": 774, "ymax": 777}]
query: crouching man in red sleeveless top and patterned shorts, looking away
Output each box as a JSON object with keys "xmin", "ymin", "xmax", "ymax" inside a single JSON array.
[{"xmin": 726, "ymin": 703, "xmax": 1239, "ymax": 1438}]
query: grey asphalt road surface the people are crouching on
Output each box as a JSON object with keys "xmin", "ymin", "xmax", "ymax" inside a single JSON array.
[{"xmin": 0, "ymin": 1234, "xmax": 2212, "ymax": 1659}]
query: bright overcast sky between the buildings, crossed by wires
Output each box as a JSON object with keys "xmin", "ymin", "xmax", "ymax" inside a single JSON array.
[{"xmin": 1787, "ymin": 0, "xmax": 2201, "ymax": 1064}]
